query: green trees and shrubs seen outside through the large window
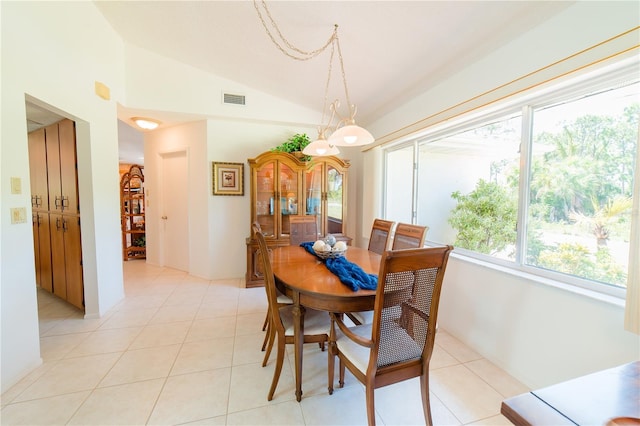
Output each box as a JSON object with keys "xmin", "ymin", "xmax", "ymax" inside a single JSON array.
[{"xmin": 449, "ymin": 104, "xmax": 640, "ymax": 286}]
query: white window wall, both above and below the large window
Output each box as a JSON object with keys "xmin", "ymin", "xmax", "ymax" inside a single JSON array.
[{"xmin": 362, "ymin": 2, "xmax": 640, "ymax": 388}]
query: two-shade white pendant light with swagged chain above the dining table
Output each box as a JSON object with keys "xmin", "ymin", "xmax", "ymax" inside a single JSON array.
[{"xmin": 253, "ymin": 0, "xmax": 375, "ymax": 156}]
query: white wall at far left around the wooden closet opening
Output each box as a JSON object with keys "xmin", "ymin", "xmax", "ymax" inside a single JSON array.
[{"xmin": 0, "ymin": 2, "xmax": 124, "ymax": 391}]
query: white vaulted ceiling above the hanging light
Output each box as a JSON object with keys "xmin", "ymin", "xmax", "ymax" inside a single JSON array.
[{"xmin": 26, "ymin": 0, "xmax": 574, "ymax": 163}]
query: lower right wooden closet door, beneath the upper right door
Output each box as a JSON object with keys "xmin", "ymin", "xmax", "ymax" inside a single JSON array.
[{"xmin": 62, "ymin": 216, "xmax": 84, "ymax": 309}]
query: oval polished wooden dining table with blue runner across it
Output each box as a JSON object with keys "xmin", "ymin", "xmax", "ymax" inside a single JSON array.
[{"xmin": 271, "ymin": 246, "xmax": 381, "ymax": 401}]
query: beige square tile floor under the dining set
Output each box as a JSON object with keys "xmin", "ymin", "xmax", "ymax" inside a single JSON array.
[{"xmin": 0, "ymin": 260, "xmax": 527, "ymax": 425}]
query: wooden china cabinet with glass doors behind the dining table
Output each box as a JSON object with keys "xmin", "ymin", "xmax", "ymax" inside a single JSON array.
[{"xmin": 245, "ymin": 151, "xmax": 351, "ymax": 287}]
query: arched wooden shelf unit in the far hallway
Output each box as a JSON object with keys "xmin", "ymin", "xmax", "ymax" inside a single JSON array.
[{"xmin": 120, "ymin": 164, "xmax": 147, "ymax": 260}]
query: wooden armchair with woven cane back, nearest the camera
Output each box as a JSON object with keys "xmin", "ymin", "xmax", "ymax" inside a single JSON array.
[{"xmin": 328, "ymin": 246, "xmax": 453, "ymax": 425}]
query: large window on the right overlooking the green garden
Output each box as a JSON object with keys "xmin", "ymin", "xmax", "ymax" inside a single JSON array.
[{"xmin": 385, "ymin": 59, "xmax": 640, "ymax": 290}]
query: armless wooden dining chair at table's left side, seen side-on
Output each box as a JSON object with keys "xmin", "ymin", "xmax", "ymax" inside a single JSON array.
[{"xmin": 255, "ymin": 233, "xmax": 331, "ymax": 401}]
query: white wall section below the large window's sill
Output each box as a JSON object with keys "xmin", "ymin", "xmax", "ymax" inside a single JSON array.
[{"xmin": 438, "ymin": 252, "xmax": 640, "ymax": 389}]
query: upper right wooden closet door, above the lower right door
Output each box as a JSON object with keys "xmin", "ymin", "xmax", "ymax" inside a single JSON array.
[{"xmin": 58, "ymin": 120, "xmax": 79, "ymax": 214}]
